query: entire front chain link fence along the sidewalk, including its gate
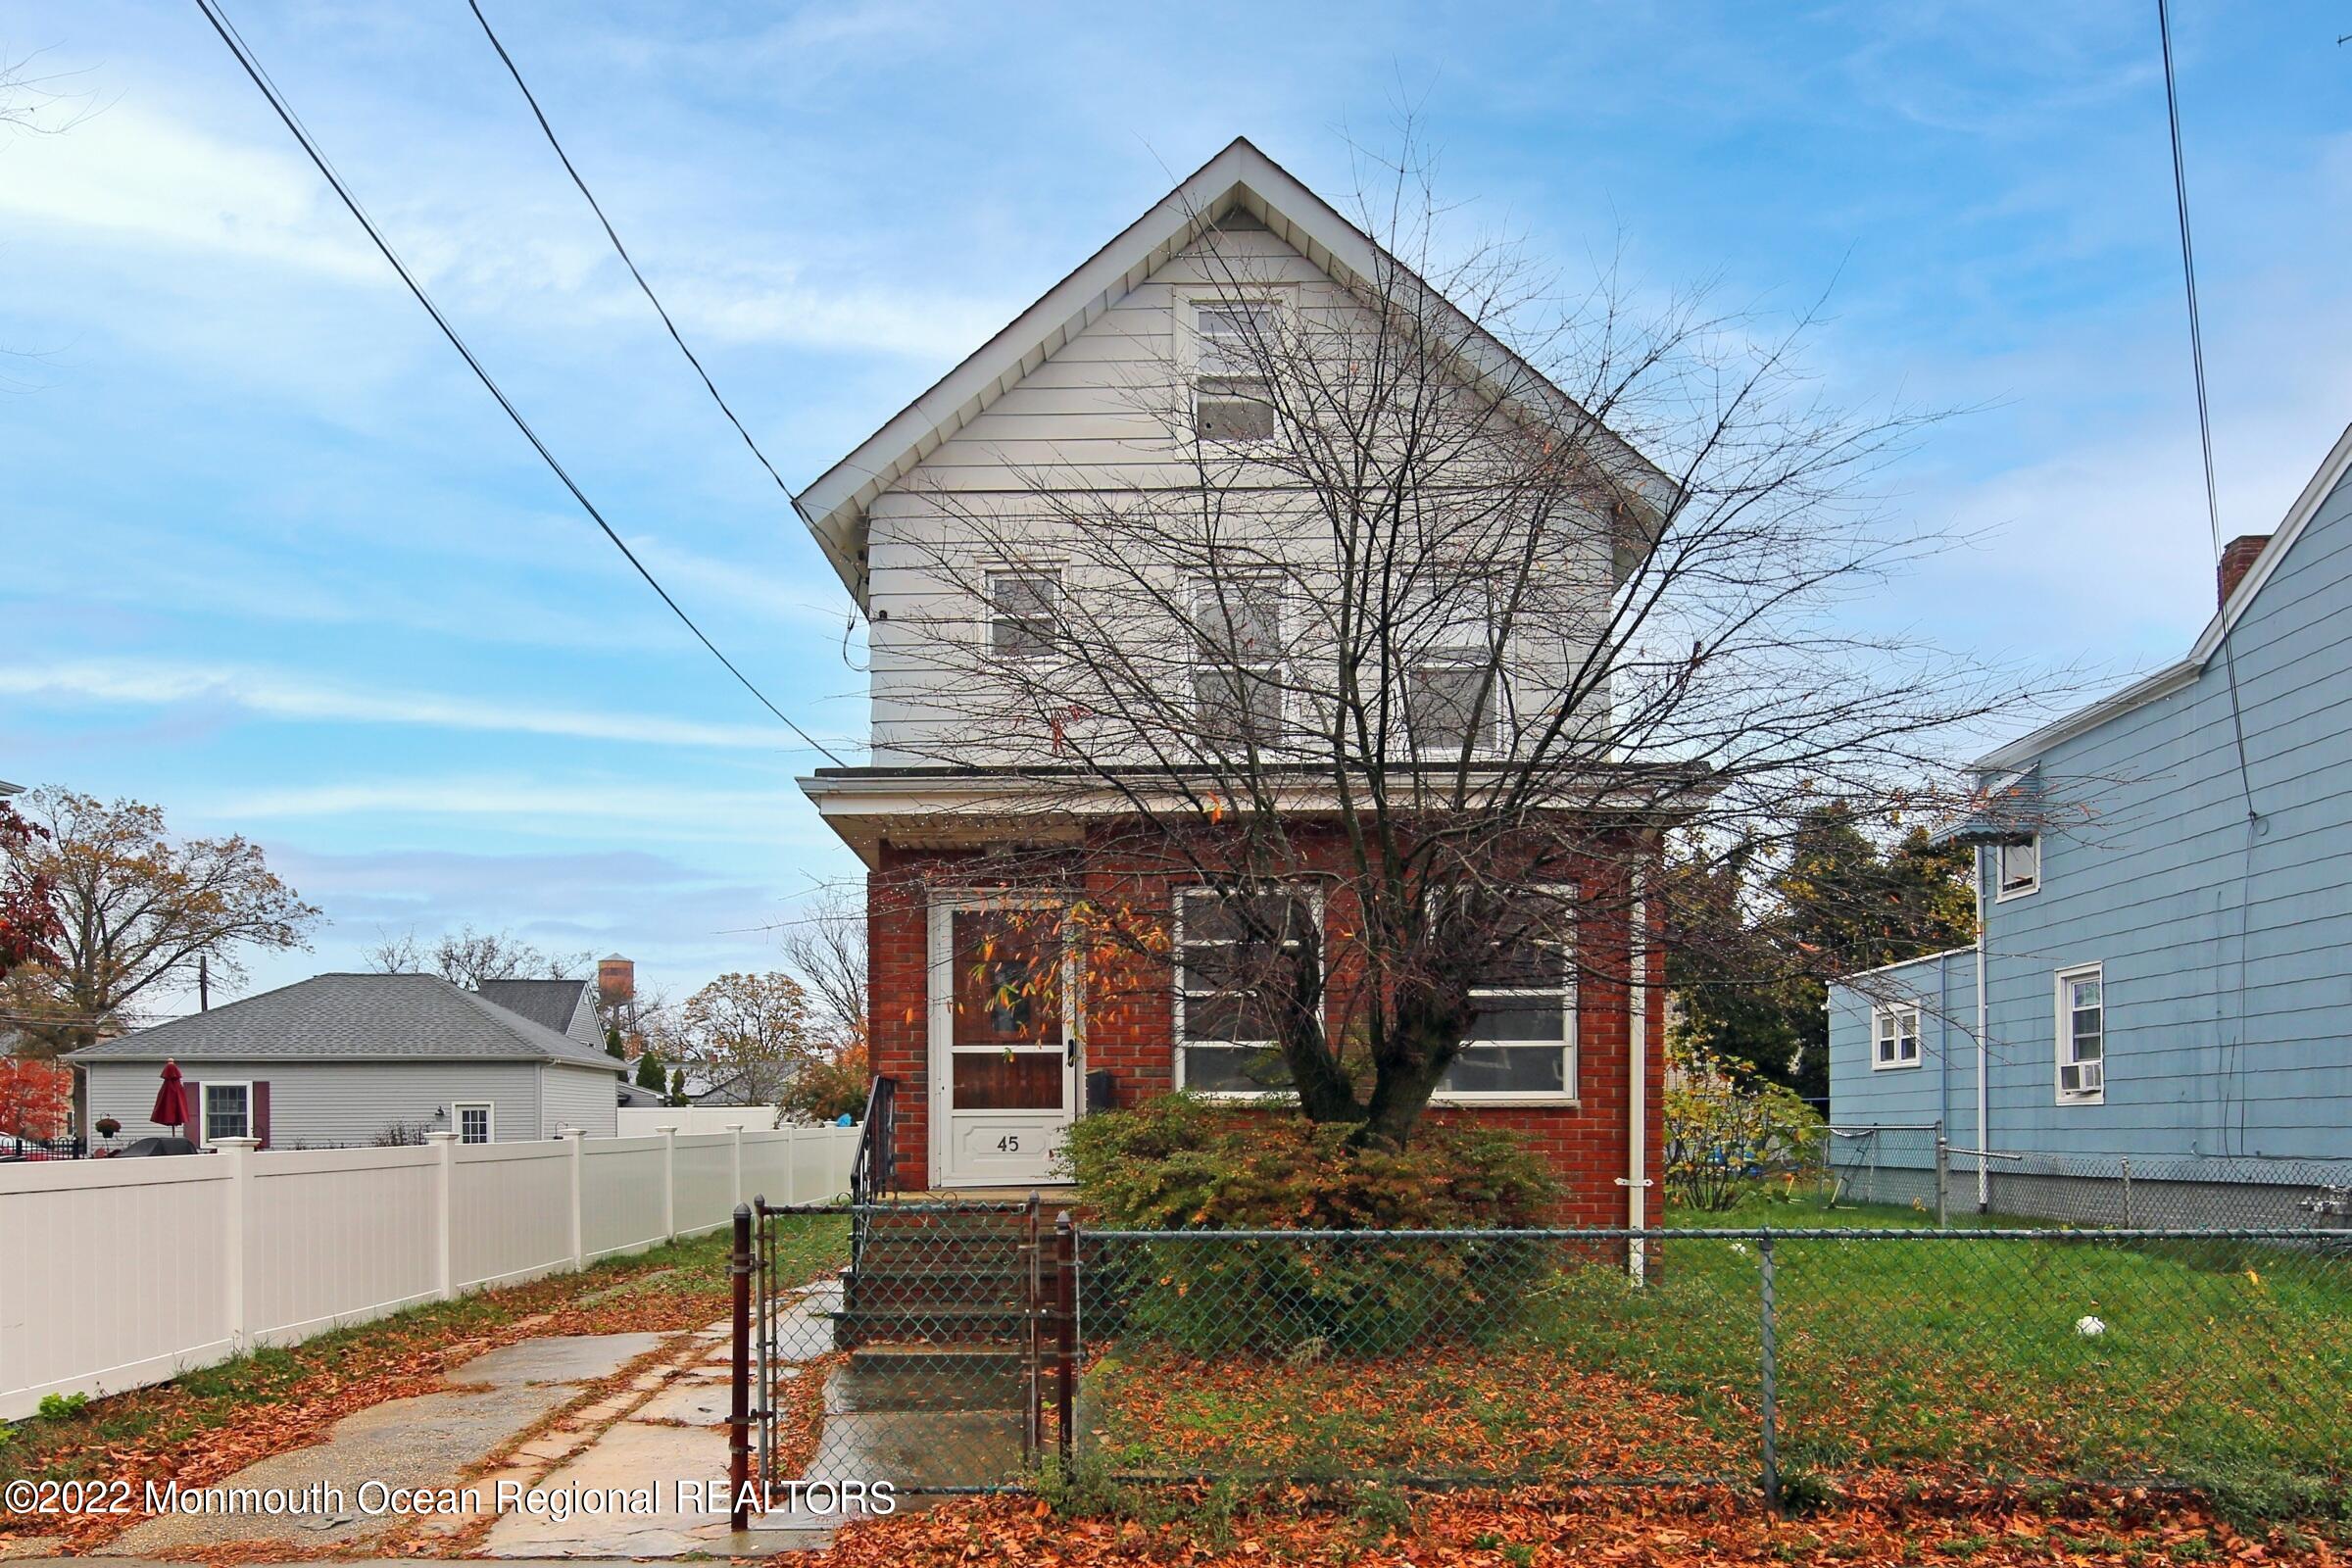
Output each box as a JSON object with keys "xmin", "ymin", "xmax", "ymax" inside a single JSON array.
[{"xmin": 739, "ymin": 1203, "xmax": 2352, "ymax": 1516}]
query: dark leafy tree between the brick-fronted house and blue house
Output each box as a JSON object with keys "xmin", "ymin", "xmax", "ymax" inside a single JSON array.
[{"xmin": 1668, "ymin": 802, "xmax": 1976, "ymax": 1102}]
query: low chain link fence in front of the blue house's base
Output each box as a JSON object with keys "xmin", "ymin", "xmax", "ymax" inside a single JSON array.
[{"xmin": 1813, "ymin": 1121, "xmax": 2352, "ymax": 1230}]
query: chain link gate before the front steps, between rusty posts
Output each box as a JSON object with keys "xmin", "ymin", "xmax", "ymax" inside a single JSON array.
[{"xmin": 734, "ymin": 1195, "xmax": 1077, "ymax": 1523}]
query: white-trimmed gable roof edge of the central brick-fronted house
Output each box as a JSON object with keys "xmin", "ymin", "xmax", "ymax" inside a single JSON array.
[{"xmin": 793, "ymin": 136, "xmax": 1675, "ymax": 607}]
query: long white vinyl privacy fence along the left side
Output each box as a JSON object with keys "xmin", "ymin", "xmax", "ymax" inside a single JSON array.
[{"xmin": 0, "ymin": 1126, "xmax": 858, "ymax": 1420}]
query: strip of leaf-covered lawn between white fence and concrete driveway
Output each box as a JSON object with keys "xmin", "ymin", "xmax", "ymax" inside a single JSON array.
[{"xmin": 0, "ymin": 1215, "xmax": 849, "ymax": 1546}]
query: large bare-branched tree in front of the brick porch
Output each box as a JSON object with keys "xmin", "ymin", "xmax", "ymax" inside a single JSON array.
[{"xmin": 872, "ymin": 140, "xmax": 2018, "ymax": 1145}]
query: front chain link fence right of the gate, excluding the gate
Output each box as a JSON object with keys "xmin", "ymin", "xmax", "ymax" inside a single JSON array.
[{"xmin": 1075, "ymin": 1230, "xmax": 2352, "ymax": 1511}]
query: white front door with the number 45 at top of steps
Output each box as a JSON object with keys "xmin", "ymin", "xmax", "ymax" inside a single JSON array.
[{"xmin": 929, "ymin": 898, "xmax": 1080, "ymax": 1187}]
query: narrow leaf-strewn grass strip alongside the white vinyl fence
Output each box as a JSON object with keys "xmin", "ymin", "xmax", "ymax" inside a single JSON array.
[{"xmin": 0, "ymin": 1215, "xmax": 849, "ymax": 1494}]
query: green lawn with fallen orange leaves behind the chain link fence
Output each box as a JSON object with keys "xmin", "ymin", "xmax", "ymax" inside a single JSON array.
[{"xmin": 1092, "ymin": 1197, "xmax": 2352, "ymax": 1519}]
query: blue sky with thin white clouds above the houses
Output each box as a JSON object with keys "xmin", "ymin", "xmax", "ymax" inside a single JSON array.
[{"xmin": 0, "ymin": 0, "xmax": 2352, "ymax": 1010}]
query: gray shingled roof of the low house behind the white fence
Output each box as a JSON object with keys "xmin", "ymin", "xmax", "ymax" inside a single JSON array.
[{"xmin": 66, "ymin": 976, "xmax": 621, "ymax": 1072}]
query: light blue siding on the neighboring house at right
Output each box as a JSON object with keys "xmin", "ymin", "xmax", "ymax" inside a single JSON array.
[{"xmin": 1830, "ymin": 453, "xmax": 2352, "ymax": 1159}]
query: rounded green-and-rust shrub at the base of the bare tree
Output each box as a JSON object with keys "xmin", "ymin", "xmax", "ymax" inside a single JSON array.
[{"xmin": 1068, "ymin": 1096, "xmax": 1557, "ymax": 1356}]
